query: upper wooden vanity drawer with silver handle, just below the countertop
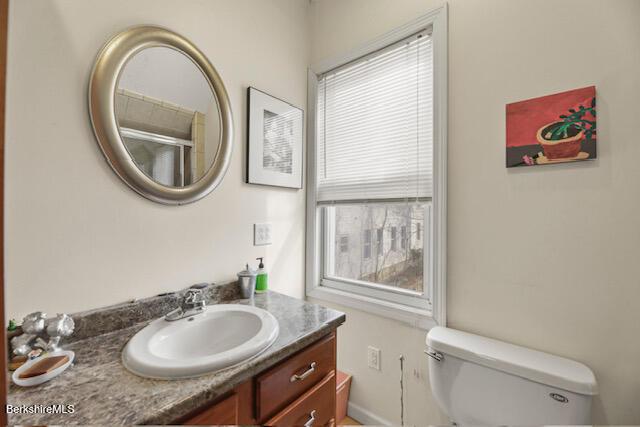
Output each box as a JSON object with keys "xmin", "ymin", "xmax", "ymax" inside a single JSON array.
[{"xmin": 256, "ymin": 333, "xmax": 336, "ymax": 420}]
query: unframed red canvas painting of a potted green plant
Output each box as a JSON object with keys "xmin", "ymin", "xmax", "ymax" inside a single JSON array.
[{"xmin": 507, "ymin": 86, "xmax": 597, "ymax": 168}]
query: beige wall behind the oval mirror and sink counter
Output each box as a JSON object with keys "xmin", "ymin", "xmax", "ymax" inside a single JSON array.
[{"xmin": 5, "ymin": 0, "xmax": 309, "ymax": 318}]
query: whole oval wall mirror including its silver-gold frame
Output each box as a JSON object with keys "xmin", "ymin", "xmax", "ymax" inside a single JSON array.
[{"xmin": 89, "ymin": 26, "xmax": 232, "ymax": 204}]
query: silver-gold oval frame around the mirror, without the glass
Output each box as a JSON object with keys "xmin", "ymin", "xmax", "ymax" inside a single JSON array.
[{"xmin": 89, "ymin": 25, "xmax": 233, "ymax": 205}]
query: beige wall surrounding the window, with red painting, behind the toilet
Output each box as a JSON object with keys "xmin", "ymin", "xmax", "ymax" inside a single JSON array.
[{"xmin": 312, "ymin": 0, "xmax": 640, "ymax": 425}]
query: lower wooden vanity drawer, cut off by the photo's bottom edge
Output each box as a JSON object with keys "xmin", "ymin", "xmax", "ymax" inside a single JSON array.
[{"xmin": 266, "ymin": 372, "xmax": 336, "ymax": 427}]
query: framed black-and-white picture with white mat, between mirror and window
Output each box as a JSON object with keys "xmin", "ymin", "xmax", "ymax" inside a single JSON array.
[{"xmin": 247, "ymin": 87, "xmax": 304, "ymax": 189}]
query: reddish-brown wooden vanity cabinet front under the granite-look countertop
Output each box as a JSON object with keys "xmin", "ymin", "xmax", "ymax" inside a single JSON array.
[{"xmin": 184, "ymin": 332, "xmax": 336, "ymax": 427}]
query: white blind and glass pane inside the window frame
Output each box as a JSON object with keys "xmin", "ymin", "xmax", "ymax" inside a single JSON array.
[{"xmin": 316, "ymin": 30, "xmax": 433, "ymax": 305}]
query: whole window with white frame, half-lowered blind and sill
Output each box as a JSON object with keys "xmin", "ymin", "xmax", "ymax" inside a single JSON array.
[{"xmin": 307, "ymin": 6, "xmax": 446, "ymax": 332}]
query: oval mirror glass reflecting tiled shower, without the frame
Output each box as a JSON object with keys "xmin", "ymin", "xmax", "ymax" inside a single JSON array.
[{"xmin": 115, "ymin": 47, "xmax": 221, "ymax": 187}]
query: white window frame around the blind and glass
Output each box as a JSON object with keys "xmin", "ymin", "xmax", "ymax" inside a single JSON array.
[{"xmin": 306, "ymin": 3, "xmax": 448, "ymax": 329}]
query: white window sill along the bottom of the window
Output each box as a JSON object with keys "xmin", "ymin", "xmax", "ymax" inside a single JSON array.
[{"xmin": 307, "ymin": 286, "xmax": 438, "ymax": 330}]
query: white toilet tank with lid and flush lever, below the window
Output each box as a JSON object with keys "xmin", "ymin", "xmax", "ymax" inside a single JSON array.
[{"xmin": 427, "ymin": 326, "xmax": 598, "ymax": 425}]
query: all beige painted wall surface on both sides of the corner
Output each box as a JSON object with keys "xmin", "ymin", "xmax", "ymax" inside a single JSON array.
[{"xmin": 5, "ymin": 0, "xmax": 640, "ymax": 425}]
